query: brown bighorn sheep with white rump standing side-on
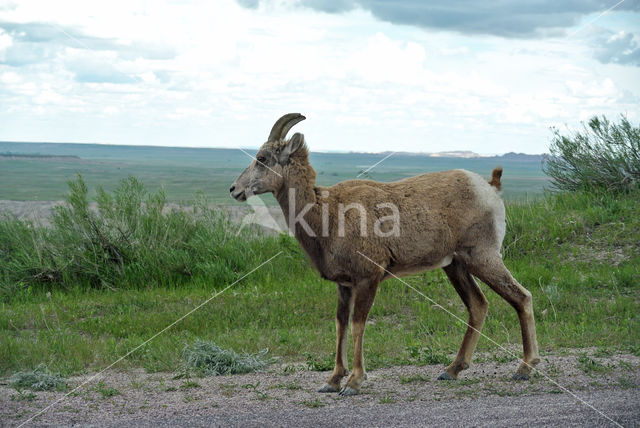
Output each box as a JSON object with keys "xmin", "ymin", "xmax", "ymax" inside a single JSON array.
[{"xmin": 229, "ymin": 113, "xmax": 540, "ymax": 395}]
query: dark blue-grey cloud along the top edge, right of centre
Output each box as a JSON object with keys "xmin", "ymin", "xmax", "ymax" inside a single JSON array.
[{"xmin": 238, "ymin": 0, "xmax": 640, "ymax": 38}]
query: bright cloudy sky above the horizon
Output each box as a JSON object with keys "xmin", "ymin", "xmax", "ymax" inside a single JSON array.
[{"xmin": 0, "ymin": 0, "xmax": 640, "ymax": 154}]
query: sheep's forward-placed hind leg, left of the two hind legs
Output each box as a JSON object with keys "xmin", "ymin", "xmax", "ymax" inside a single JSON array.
[{"xmin": 438, "ymin": 260, "xmax": 489, "ymax": 380}]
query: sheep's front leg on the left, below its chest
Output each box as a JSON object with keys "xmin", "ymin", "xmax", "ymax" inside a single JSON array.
[{"xmin": 318, "ymin": 284, "xmax": 353, "ymax": 392}]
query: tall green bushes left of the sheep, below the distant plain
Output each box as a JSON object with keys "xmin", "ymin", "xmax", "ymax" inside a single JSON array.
[{"xmin": 0, "ymin": 176, "xmax": 285, "ymax": 300}]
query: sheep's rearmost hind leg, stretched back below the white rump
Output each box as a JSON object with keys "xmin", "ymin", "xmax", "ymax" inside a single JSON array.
[{"xmin": 469, "ymin": 253, "xmax": 540, "ymax": 380}]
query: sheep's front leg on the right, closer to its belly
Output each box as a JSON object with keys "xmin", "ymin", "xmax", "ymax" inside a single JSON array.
[{"xmin": 340, "ymin": 281, "xmax": 378, "ymax": 396}]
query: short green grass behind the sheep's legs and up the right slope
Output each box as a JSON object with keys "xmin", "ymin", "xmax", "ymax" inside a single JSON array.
[{"xmin": 0, "ymin": 181, "xmax": 640, "ymax": 378}]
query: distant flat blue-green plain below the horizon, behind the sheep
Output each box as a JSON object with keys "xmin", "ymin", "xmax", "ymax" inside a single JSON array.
[{"xmin": 0, "ymin": 142, "xmax": 547, "ymax": 201}]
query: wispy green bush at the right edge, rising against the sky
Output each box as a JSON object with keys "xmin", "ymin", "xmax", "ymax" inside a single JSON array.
[{"xmin": 542, "ymin": 116, "xmax": 640, "ymax": 192}]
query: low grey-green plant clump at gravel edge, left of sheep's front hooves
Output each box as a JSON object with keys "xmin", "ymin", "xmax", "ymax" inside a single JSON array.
[{"xmin": 182, "ymin": 340, "xmax": 273, "ymax": 376}]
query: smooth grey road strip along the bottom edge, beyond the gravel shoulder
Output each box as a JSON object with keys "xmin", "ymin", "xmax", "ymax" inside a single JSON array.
[{"xmin": 104, "ymin": 390, "xmax": 640, "ymax": 427}]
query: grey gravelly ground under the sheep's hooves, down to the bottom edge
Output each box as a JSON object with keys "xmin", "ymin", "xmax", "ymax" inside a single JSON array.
[{"xmin": 0, "ymin": 352, "xmax": 640, "ymax": 427}]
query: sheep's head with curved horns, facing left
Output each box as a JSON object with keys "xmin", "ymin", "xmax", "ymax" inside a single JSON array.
[{"xmin": 229, "ymin": 113, "xmax": 306, "ymax": 201}]
